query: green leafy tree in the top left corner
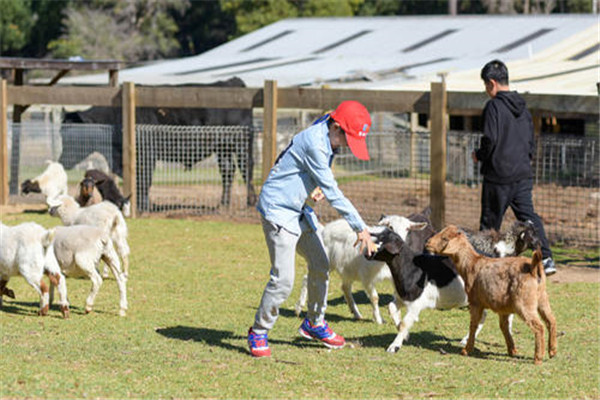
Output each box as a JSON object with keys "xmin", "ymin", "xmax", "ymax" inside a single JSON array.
[{"xmin": 0, "ymin": 0, "xmax": 34, "ymax": 56}]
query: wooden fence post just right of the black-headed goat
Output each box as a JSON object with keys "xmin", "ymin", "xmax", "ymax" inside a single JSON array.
[{"xmin": 122, "ymin": 82, "xmax": 137, "ymax": 218}]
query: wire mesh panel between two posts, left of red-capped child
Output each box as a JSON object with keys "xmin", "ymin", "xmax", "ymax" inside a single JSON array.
[{"xmin": 136, "ymin": 125, "xmax": 256, "ymax": 214}]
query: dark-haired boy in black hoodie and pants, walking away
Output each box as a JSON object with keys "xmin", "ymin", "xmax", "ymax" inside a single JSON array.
[{"xmin": 472, "ymin": 60, "xmax": 556, "ymax": 275}]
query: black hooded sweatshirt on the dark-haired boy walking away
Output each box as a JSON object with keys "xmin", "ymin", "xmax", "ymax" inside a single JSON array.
[{"xmin": 475, "ymin": 91, "xmax": 535, "ymax": 184}]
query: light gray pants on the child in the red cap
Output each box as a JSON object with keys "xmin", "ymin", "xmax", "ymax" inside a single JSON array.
[{"xmin": 252, "ymin": 217, "xmax": 329, "ymax": 334}]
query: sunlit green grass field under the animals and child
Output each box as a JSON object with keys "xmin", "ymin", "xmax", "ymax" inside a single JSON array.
[{"xmin": 0, "ymin": 214, "xmax": 600, "ymax": 399}]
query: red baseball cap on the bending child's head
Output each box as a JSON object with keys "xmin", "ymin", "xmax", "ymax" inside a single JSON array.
[{"xmin": 330, "ymin": 100, "xmax": 371, "ymax": 161}]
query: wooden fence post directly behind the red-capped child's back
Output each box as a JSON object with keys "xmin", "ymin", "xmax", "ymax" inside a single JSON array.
[{"xmin": 262, "ymin": 81, "xmax": 277, "ymax": 182}]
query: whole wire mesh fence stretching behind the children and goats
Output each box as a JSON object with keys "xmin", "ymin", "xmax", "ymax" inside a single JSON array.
[{"xmin": 8, "ymin": 122, "xmax": 600, "ymax": 246}]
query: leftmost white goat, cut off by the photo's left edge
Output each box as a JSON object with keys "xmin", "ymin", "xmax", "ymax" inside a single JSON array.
[{"xmin": 0, "ymin": 222, "xmax": 69, "ymax": 318}]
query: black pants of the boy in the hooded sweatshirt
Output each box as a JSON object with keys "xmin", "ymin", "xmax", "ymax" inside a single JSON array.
[{"xmin": 479, "ymin": 179, "xmax": 552, "ymax": 258}]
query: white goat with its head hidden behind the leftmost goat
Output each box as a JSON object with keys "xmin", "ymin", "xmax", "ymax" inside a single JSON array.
[{"xmin": 51, "ymin": 225, "xmax": 127, "ymax": 316}]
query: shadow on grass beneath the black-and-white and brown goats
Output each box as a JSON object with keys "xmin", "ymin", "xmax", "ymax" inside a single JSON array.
[{"xmin": 356, "ymin": 331, "xmax": 531, "ymax": 362}]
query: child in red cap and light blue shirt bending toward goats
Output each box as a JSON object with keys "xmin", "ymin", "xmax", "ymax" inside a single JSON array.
[{"xmin": 248, "ymin": 101, "xmax": 375, "ymax": 357}]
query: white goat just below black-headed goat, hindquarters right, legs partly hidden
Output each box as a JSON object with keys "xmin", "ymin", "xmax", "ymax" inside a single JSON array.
[{"xmin": 50, "ymin": 195, "xmax": 130, "ymax": 277}]
